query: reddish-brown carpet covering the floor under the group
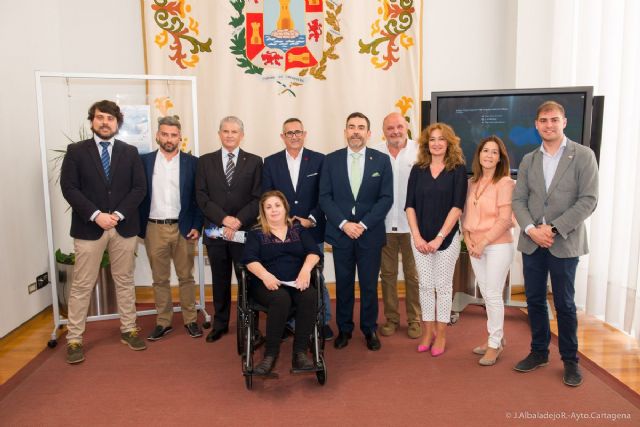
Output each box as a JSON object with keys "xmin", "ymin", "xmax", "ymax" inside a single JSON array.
[{"xmin": 0, "ymin": 306, "xmax": 640, "ymax": 426}]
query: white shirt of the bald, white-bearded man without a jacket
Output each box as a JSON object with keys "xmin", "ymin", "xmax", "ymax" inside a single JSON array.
[{"xmin": 373, "ymin": 139, "xmax": 418, "ymax": 233}]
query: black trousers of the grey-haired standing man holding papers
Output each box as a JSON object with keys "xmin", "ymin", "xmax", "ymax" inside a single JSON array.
[{"xmin": 207, "ymin": 241, "xmax": 244, "ymax": 330}]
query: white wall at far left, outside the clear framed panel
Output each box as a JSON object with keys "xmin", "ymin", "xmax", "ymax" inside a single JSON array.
[{"xmin": 0, "ymin": 0, "xmax": 144, "ymax": 337}]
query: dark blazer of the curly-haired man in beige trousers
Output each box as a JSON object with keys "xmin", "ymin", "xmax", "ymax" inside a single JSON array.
[{"xmin": 60, "ymin": 138, "xmax": 147, "ymax": 240}]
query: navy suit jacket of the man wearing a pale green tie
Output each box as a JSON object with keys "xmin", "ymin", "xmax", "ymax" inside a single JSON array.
[{"xmin": 320, "ymin": 148, "xmax": 393, "ymax": 248}]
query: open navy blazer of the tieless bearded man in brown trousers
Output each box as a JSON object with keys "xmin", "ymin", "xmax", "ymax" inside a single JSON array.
[{"xmin": 138, "ymin": 150, "xmax": 203, "ymax": 239}]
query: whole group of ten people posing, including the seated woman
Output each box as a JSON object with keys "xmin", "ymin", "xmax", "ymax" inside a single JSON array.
[{"xmin": 61, "ymin": 101, "xmax": 597, "ymax": 386}]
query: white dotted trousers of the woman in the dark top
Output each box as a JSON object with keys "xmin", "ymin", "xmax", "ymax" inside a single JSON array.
[{"xmin": 411, "ymin": 233, "xmax": 460, "ymax": 323}]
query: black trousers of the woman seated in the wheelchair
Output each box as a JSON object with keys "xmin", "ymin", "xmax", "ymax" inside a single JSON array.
[{"xmin": 249, "ymin": 279, "xmax": 318, "ymax": 356}]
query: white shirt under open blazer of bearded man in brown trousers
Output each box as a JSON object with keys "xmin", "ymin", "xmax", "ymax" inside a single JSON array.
[{"xmin": 149, "ymin": 150, "xmax": 182, "ymax": 219}]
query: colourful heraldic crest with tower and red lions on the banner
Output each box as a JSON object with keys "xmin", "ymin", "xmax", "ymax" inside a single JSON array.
[{"xmin": 229, "ymin": 0, "xmax": 343, "ymax": 96}]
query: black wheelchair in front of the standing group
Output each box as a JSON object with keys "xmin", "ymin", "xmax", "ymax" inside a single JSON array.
[{"xmin": 236, "ymin": 262, "xmax": 327, "ymax": 390}]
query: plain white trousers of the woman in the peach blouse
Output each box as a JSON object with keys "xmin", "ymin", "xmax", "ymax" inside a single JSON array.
[{"xmin": 471, "ymin": 243, "xmax": 513, "ymax": 348}]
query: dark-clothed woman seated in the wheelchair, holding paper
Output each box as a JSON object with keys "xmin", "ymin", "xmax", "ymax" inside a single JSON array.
[{"xmin": 243, "ymin": 191, "xmax": 321, "ymax": 375}]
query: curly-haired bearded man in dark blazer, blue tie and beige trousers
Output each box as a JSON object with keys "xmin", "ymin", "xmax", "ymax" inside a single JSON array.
[{"xmin": 60, "ymin": 100, "xmax": 147, "ymax": 364}]
